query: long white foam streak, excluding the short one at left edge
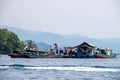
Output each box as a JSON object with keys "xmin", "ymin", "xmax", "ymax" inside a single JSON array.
[{"xmin": 24, "ymin": 67, "xmax": 120, "ymax": 72}]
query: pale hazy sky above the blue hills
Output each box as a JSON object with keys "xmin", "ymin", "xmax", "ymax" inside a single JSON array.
[{"xmin": 0, "ymin": 0, "xmax": 120, "ymax": 39}]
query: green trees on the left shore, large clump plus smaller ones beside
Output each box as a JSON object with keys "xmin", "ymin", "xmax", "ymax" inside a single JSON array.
[{"xmin": 0, "ymin": 28, "xmax": 37, "ymax": 54}]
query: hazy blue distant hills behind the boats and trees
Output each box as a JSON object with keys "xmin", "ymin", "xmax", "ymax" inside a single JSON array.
[{"xmin": 0, "ymin": 25, "xmax": 120, "ymax": 53}]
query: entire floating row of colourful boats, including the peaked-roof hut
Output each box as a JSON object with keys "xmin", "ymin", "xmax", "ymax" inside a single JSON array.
[{"xmin": 8, "ymin": 42, "xmax": 116, "ymax": 58}]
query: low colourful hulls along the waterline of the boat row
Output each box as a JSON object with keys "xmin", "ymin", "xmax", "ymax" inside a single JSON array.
[{"xmin": 8, "ymin": 53, "xmax": 116, "ymax": 58}]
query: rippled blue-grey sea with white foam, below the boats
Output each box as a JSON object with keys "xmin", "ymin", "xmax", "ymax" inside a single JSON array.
[{"xmin": 0, "ymin": 55, "xmax": 120, "ymax": 80}]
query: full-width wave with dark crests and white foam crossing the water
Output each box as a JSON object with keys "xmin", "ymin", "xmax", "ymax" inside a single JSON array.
[{"xmin": 0, "ymin": 64, "xmax": 120, "ymax": 72}]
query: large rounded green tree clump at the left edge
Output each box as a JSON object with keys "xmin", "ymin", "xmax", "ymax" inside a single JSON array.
[{"xmin": 0, "ymin": 29, "xmax": 24, "ymax": 53}]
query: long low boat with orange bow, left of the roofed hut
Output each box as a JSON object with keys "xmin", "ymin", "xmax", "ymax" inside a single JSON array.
[{"xmin": 8, "ymin": 50, "xmax": 62, "ymax": 58}]
